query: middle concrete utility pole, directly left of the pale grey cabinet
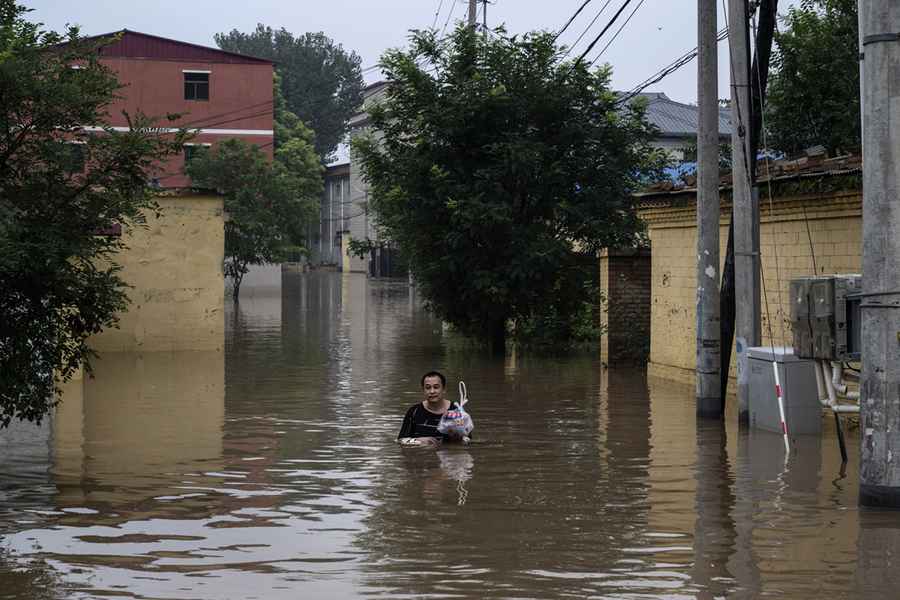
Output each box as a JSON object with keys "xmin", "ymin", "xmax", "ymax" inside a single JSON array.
[{"xmin": 722, "ymin": 0, "xmax": 756, "ymax": 423}]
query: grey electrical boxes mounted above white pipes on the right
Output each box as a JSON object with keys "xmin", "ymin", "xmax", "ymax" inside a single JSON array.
[{"xmin": 790, "ymin": 274, "xmax": 862, "ymax": 361}]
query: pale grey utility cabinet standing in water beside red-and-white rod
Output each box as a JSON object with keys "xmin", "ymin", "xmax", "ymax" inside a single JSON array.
[{"xmin": 747, "ymin": 346, "xmax": 822, "ymax": 436}]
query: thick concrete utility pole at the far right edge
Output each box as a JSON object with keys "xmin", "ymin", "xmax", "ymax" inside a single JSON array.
[{"xmin": 859, "ymin": 0, "xmax": 900, "ymax": 509}]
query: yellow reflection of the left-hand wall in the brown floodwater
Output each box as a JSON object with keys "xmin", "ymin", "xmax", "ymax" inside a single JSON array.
[{"xmin": 53, "ymin": 352, "xmax": 225, "ymax": 507}]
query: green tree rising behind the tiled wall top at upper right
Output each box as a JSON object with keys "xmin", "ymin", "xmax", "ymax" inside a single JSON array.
[{"xmin": 766, "ymin": 0, "xmax": 862, "ymax": 156}]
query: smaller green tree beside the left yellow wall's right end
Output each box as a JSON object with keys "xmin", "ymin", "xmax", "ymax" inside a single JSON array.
[{"xmin": 187, "ymin": 132, "xmax": 322, "ymax": 301}]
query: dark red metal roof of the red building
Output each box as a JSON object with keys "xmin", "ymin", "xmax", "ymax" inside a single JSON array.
[{"xmin": 90, "ymin": 29, "xmax": 273, "ymax": 65}]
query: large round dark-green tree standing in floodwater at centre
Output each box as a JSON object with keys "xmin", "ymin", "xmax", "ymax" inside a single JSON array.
[{"xmin": 354, "ymin": 28, "xmax": 665, "ymax": 352}]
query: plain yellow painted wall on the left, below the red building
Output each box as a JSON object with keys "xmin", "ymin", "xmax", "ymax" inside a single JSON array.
[{"xmin": 90, "ymin": 194, "xmax": 225, "ymax": 352}]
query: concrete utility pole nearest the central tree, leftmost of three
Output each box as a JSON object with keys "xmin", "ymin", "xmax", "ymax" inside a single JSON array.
[{"xmin": 697, "ymin": 0, "xmax": 722, "ymax": 417}]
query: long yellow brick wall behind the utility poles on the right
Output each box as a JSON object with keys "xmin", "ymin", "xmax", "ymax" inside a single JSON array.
[{"xmin": 641, "ymin": 192, "xmax": 862, "ymax": 382}]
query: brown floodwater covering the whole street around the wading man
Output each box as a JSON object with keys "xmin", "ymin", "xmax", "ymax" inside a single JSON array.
[{"xmin": 0, "ymin": 273, "xmax": 900, "ymax": 599}]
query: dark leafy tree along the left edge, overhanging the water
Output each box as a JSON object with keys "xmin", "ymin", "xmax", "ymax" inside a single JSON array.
[{"xmin": 0, "ymin": 0, "xmax": 185, "ymax": 427}]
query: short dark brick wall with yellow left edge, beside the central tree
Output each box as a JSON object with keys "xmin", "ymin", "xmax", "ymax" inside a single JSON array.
[{"xmin": 600, "ymin": 249, "xmax": 651, "ymax": 364}]
